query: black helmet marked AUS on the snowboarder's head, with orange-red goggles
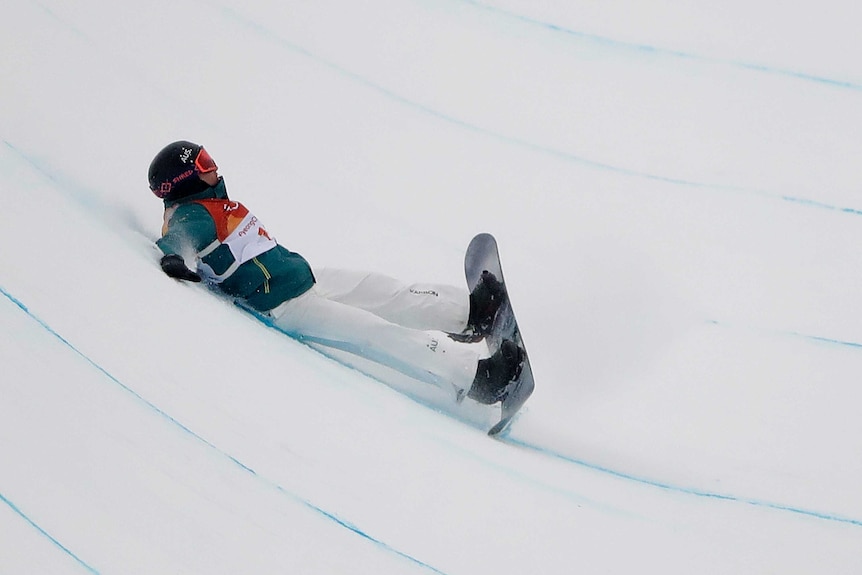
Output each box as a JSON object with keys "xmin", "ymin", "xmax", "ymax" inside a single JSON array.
[{"xmin": 148, "ymin": 140, "xmax": 218, "ymax": 200}]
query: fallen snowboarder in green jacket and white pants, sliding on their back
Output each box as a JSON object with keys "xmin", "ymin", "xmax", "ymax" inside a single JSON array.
[{"xmin": 148, "ymin": 141, "xmax": 522, "ymax": 405}]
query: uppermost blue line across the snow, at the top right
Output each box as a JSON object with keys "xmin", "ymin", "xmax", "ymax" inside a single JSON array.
[{"xmin": 459, "ymin": 0, "xmax": 862, "ymax": 91}]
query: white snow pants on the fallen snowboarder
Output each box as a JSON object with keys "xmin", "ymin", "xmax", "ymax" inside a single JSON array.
[{"xmin": 269, "ymin": 268, "xmax": 479, "ymax": 391}]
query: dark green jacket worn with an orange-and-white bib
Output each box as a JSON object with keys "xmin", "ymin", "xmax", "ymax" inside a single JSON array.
[{"xmin": 156, "ymin": 178, "xmax": 314, "ymax": 312}]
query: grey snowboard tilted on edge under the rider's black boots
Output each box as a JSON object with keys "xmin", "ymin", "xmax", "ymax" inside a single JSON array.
[{"xmin": 464, "ymin": 234, "xmax": 536, "ymax": 436}]
